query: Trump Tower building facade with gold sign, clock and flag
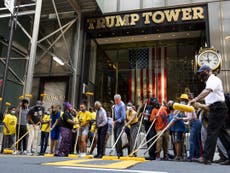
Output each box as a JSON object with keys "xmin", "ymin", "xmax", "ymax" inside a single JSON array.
[{"xmin": 0, "ymin": 0, "xmax": 230, "ymax": 106}]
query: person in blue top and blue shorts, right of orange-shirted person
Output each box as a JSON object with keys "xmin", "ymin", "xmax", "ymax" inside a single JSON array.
[{"xmin": 168, "ymin": 101, "xmax": 186, "ymax": 161}]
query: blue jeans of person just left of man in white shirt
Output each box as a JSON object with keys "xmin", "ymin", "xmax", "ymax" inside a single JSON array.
[{"xmin": 189, "ymin": 120, "xmax": 201, "ymax": 159}]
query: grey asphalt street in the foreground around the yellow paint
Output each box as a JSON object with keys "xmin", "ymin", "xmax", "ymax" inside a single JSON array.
[{"xmin": 0, "ymin": 155, "xmax": 230, "ymax": 173}]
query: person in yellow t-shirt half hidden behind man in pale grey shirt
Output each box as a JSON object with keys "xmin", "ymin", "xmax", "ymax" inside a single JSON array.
[{"xmin": 89, "ymin": 107, "xmax": 97, "ymax": 154}]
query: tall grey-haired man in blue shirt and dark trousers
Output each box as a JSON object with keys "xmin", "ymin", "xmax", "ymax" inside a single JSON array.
[{"xmin": 113, "ymin": 94, "xmax": 126, "ymax": 157}]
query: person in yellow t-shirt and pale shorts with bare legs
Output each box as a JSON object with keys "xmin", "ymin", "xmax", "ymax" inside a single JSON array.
[{"xmin": 77, "ymin": 103, "xmax": 91, "ymax": 157}]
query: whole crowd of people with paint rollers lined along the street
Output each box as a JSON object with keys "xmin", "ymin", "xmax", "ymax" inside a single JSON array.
[{"xmin": 2, "ymin": 64, "xmax": 230, "ymax": 165}]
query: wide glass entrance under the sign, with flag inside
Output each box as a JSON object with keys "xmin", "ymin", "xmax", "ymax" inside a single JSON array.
[{"xmin": 95, "ymin": 38, "xmax": 200, "ymax": 105}]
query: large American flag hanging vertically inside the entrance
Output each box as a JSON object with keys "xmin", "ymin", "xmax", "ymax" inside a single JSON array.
[{"xmin": 129, "ymin": 47, "xmax": 167, "ymax": 105}]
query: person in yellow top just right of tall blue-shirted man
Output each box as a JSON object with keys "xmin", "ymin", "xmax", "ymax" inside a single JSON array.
[{"xmin": 125, "ymin": 102, "xmax": 138, "ymax": 152}]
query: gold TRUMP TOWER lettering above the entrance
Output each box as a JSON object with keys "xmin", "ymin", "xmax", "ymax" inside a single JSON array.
[{"xmin": 87, "ymin": 7, "xmax": 205, "ymax": 30}]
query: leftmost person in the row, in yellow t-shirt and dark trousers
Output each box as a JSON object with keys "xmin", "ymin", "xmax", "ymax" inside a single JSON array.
[{"xmin": 3, "ymin": 107, "xmax": 17, "ymax": 148}]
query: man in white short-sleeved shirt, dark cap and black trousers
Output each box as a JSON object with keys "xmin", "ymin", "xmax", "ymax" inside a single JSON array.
[{"xmin": 189, "ymin": 65, "xmax": 230, "ymax": 164}]
